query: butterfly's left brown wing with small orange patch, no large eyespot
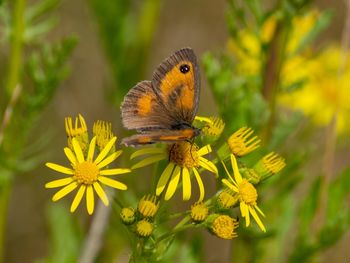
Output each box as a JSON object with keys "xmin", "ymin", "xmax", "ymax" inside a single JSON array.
[{"xmin": 121, "ymin": 81, "xmax": 173, "ymax": 131}]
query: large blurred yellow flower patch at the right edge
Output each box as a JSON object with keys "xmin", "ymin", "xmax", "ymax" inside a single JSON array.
[{"xmin": 279, "ymin": 46, "xmax": 350, "ymax": 134}]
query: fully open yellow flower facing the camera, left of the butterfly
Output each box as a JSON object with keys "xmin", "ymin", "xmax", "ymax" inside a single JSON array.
[{"xmin": 45, "ymin": 137, "xmax": 131, "ymax": 215}]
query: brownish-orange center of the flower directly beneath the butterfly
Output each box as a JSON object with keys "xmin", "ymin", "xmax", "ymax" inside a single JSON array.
[{"xmin": 168, "ymin": 142, "xmax": 199, "ymax": 168}]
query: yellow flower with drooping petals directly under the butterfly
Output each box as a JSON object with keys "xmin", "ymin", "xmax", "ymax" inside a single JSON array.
[{"xmin": 130, "ymin": 141, "xmax": 218, "ymax": 201}]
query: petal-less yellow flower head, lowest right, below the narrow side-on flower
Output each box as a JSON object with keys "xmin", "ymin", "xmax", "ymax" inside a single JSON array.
[{"xmin": 211, "ymin": 214, "xmax": 238, "ymax": 239}]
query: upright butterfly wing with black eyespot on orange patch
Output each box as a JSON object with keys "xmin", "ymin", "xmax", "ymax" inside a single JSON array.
[{"xmin": 152, "ymin": 48, "xmax": 200, "ymax": 127}]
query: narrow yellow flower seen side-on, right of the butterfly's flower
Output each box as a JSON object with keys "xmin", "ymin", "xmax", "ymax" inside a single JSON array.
[{"xmin": 222, "ymin": 154, "xmax": 266, "ymax": 232}]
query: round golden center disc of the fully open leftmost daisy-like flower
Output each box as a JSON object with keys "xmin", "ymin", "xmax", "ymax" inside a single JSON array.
[{"xmin": 74, "ymin": 162, "xmax": 100, "ymax": 184}]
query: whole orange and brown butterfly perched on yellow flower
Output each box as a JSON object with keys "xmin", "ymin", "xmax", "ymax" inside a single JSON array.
[{"xmin": 121, "ymin": 48, "xmax": 200, "ymax": 146}]
